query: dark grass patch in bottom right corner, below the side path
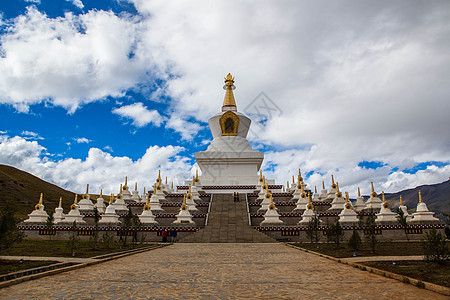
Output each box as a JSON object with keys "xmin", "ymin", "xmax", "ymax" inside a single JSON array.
[{"xmin": 364, "ymin": 260, "xmax": 450, "ymax": 288}]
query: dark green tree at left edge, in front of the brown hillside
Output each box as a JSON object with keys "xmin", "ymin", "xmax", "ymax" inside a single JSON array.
[{"xmin": 0, "ymin": 201, "xmax": 23, "ymax": 250}]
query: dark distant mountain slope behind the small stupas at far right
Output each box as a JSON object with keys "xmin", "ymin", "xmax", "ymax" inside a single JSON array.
[{"xmin": 380, "ymin": 180, "xmax": 450, "ymax": 217}]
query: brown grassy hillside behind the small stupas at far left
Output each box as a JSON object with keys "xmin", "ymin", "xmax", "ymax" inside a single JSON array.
[{"xmin": 0, "ymin": 165, "xmax": 75, "ymax": 219}]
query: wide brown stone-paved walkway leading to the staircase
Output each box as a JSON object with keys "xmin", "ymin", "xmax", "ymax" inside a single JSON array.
[{"xmin": 0, "ymin": 243, "xmax": 446, "ymax": 299}]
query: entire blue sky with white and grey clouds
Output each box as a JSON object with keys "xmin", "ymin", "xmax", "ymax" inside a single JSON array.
[{"xmin": 0, "ymin": 0, "xmax": 450, "ymax": 196}]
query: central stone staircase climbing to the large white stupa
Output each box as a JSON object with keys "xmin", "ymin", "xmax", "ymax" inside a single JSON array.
[{"xmin": 180, "ymin": 194, "xmax": 276, "ymax": 243}]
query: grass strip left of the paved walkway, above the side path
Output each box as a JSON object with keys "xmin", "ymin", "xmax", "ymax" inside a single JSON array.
[{"xmin": 0, "ymin": 240, "xmax": 148, "ymax": 257}]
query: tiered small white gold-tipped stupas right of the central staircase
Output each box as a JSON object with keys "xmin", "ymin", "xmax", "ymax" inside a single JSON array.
[{"xmin": 257, "ymin": 170, "xmax": 439, "ymax": 225}]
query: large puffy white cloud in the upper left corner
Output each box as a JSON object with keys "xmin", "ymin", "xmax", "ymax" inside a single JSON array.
[{"xmin": 0, "ymin": 6, "xmax": 150, "ymax": 112}]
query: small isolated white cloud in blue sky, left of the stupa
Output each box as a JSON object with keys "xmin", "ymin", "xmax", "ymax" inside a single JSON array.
[{"xmin": 113, "ymin": 102, "xmax": 163, "ymax": 127}]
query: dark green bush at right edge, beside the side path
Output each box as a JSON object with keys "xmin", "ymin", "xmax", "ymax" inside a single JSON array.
[{"xmin": 422, "ymin": 228, "xmax": 450, "ymax": 264}]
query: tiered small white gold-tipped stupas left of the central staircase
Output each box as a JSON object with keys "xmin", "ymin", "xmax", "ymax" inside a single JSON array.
[{"xmin": 24, "ymin": 173, "xmax": 203, "ymax": 226}]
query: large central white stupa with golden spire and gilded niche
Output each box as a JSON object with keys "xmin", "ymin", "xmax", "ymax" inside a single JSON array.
[{"xmin": 195, "ymin": 74, "xmax": 264, "ymax": 186}]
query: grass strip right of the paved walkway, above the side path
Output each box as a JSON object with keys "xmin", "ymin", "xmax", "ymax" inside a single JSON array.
[{"xmin": 292, "ymin": 241, "xmax": 442, "ymax": 258}]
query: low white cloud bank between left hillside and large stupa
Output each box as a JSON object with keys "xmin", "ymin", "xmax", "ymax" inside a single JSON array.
[{"xmin": 0, "ymin": 136, "xmax": 192, "ymax": 193}]
